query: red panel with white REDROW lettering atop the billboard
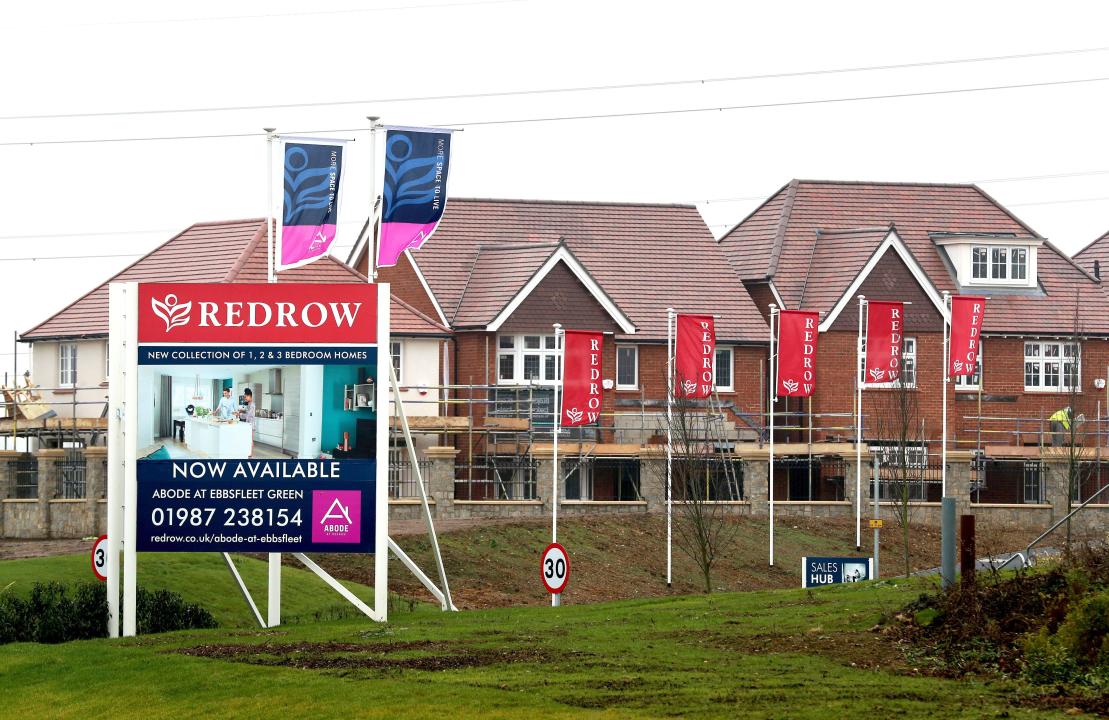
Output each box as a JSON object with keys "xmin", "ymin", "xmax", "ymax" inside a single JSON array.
[{"xmin": 139, "ymin": 283, "xmax": 377, "ymax": 345}]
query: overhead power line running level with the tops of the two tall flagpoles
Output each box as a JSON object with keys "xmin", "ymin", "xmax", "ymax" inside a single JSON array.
[{"xmin": 0, "ymin": 77, "xmax": 1109, "ymax": 148}]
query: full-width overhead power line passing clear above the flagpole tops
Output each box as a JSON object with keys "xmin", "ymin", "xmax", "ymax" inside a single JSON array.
[{"xmin": 0, "ymin": 43, "xmax": 1109, "ymax": 121}]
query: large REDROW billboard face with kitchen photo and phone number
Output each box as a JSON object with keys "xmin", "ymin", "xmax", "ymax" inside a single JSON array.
[{"xmin": 135, "ymin": 283, "xmax": 388, "ymax": 552}]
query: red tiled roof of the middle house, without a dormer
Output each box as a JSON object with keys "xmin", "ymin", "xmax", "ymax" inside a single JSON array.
[{"xmin": 401, "ymin": 197, "xmax": 766, "ymax": 342}]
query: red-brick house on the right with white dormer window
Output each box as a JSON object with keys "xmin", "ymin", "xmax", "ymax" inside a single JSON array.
[{"xmin": 720, "ymin": 180, "xmax": 1109, "ymax": 501}]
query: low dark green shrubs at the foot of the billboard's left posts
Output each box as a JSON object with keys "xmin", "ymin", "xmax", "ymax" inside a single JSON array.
[{"xmin": 0, "ymin": 582, "xmax": 216, "ymax": 645}]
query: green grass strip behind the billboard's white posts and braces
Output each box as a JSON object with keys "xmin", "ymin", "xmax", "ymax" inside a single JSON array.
[{"xmin": 0, "ymin": 552, "xmax": 425, "ymax": 627}]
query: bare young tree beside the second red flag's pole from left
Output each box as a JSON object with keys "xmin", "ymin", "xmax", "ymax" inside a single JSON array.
[{"xmin": 662, "ymin": 394, "xmax": 742, "ymax": 592}]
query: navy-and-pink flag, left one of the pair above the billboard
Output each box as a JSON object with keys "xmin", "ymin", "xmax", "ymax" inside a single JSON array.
[{"xmin": 277, "ymin": 140, "xmax": 346, "ymax": 270}]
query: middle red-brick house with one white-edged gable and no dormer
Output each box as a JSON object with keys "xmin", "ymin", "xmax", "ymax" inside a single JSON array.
[{"xmin": 349, "ymin": 199, "xmax": 766, "ymax": 500}]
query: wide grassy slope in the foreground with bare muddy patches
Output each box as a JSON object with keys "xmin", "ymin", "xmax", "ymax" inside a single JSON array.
[{"xmin": 0, "ymin": 556, "xmax": 1059, "ymax": 719}]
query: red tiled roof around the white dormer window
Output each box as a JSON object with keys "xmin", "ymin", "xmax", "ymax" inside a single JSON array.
[{"xmin": 721, "ymin": 180, "xmax": 1109, "ymax": 334}]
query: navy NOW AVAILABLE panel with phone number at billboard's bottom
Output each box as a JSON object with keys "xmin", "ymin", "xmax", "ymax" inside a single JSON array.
[{"xmin": 136, "ymin": 458, "xmax": 377, "ymax": 552}]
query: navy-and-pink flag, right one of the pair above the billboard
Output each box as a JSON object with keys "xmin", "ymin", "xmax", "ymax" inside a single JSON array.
[{"xmin": 377, "ymin": 128, "xmax": 451, "ymax": 267}]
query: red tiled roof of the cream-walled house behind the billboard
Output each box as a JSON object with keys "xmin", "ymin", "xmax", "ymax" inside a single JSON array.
[{"xmin": 20, "ymin": 217, "xmax": 445, "ymax": 341}]
